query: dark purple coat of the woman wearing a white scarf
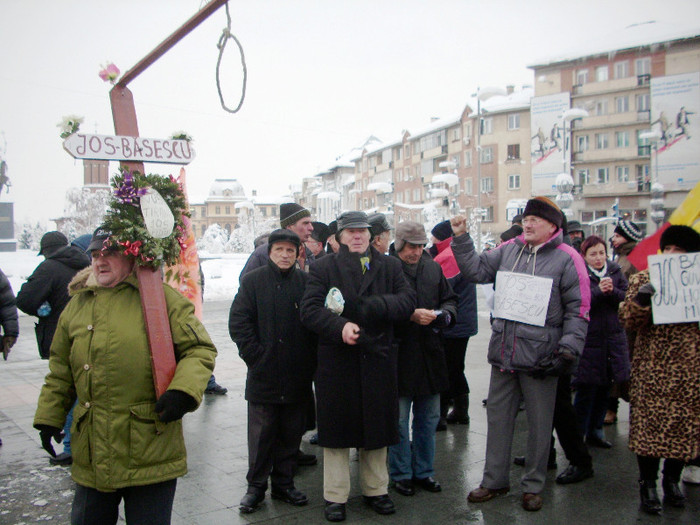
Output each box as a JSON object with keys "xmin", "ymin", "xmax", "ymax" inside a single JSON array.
[{"xmin": 572, "ymin": 261, "xmax": 630, "ymax": 386}]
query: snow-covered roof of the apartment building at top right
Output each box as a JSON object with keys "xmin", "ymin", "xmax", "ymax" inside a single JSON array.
[{"xmin": 528, "ymin": 22, "xmax": 700, "ymax": 69}]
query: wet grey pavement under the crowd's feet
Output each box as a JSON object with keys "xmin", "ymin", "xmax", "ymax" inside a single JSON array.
[{"xmin": 0, "ymin": 301, "xmax": 700, "ymax": 525}]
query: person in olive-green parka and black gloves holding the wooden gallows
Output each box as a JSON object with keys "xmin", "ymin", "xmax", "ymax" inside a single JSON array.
[{"xmin": 34, "ymin": 227, "xmax": 216, "ymax": 525}]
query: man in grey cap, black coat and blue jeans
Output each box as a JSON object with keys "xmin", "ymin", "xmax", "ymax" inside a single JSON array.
[{"xmin": 389, "ymin": 221, "xmax": 457, "ymax": 496}]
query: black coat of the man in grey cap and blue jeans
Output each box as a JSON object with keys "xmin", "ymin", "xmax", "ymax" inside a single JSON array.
[{"xmin": 396, "ymin": 252, "xmax": 457, "ymax": 397}]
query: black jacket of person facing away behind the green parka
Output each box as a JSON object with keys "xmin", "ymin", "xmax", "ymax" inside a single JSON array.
[{"xmin": 17, "ymin": 246, "xmax": 90, "ymax": 359}]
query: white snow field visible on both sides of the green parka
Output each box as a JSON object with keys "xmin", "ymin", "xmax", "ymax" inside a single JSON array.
[{"xmin": 0, "ymin": 250, "xmax": 248, "ymax": 315}]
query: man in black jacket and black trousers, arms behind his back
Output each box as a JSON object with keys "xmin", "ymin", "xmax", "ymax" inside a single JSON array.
[{"xmin": 228, "ymin": 230, "xmax": 316, "ymax": 514}]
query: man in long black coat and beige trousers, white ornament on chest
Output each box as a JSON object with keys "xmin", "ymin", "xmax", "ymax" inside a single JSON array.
[{"xmin": 301, "ymin": 211, "xmax": 415, "ymax": 521}]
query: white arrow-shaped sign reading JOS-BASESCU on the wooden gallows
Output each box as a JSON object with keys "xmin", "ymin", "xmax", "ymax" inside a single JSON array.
[{"xmin": 63, "ymin": 133, "xmax": 194, "ymax": 164}]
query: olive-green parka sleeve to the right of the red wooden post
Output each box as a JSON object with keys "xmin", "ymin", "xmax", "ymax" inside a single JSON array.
[{"xmin": 164, "ymin": 285, "xmax": 216, "ymax": 405}]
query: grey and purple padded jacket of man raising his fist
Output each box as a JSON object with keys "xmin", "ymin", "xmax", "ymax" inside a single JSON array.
[{"xmin": 452, "ymin": 230, "xmax": 591, "ymax": 372}]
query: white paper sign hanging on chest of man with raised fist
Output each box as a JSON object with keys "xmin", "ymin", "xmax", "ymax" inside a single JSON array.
[{"xmin": 493, "ymin": 271, "xmax": 553, "ymax": 326}]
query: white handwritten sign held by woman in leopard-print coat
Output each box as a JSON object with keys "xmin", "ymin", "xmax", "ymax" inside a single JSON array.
[{"xmin": 649, "ymin": 253, "xmax": 700, "ymax": 324}]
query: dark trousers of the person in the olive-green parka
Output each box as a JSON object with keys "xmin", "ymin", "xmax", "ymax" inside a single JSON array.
[{"xmin": 70, "ymin": 479, "xmax": 177, "ymax": 525}]
